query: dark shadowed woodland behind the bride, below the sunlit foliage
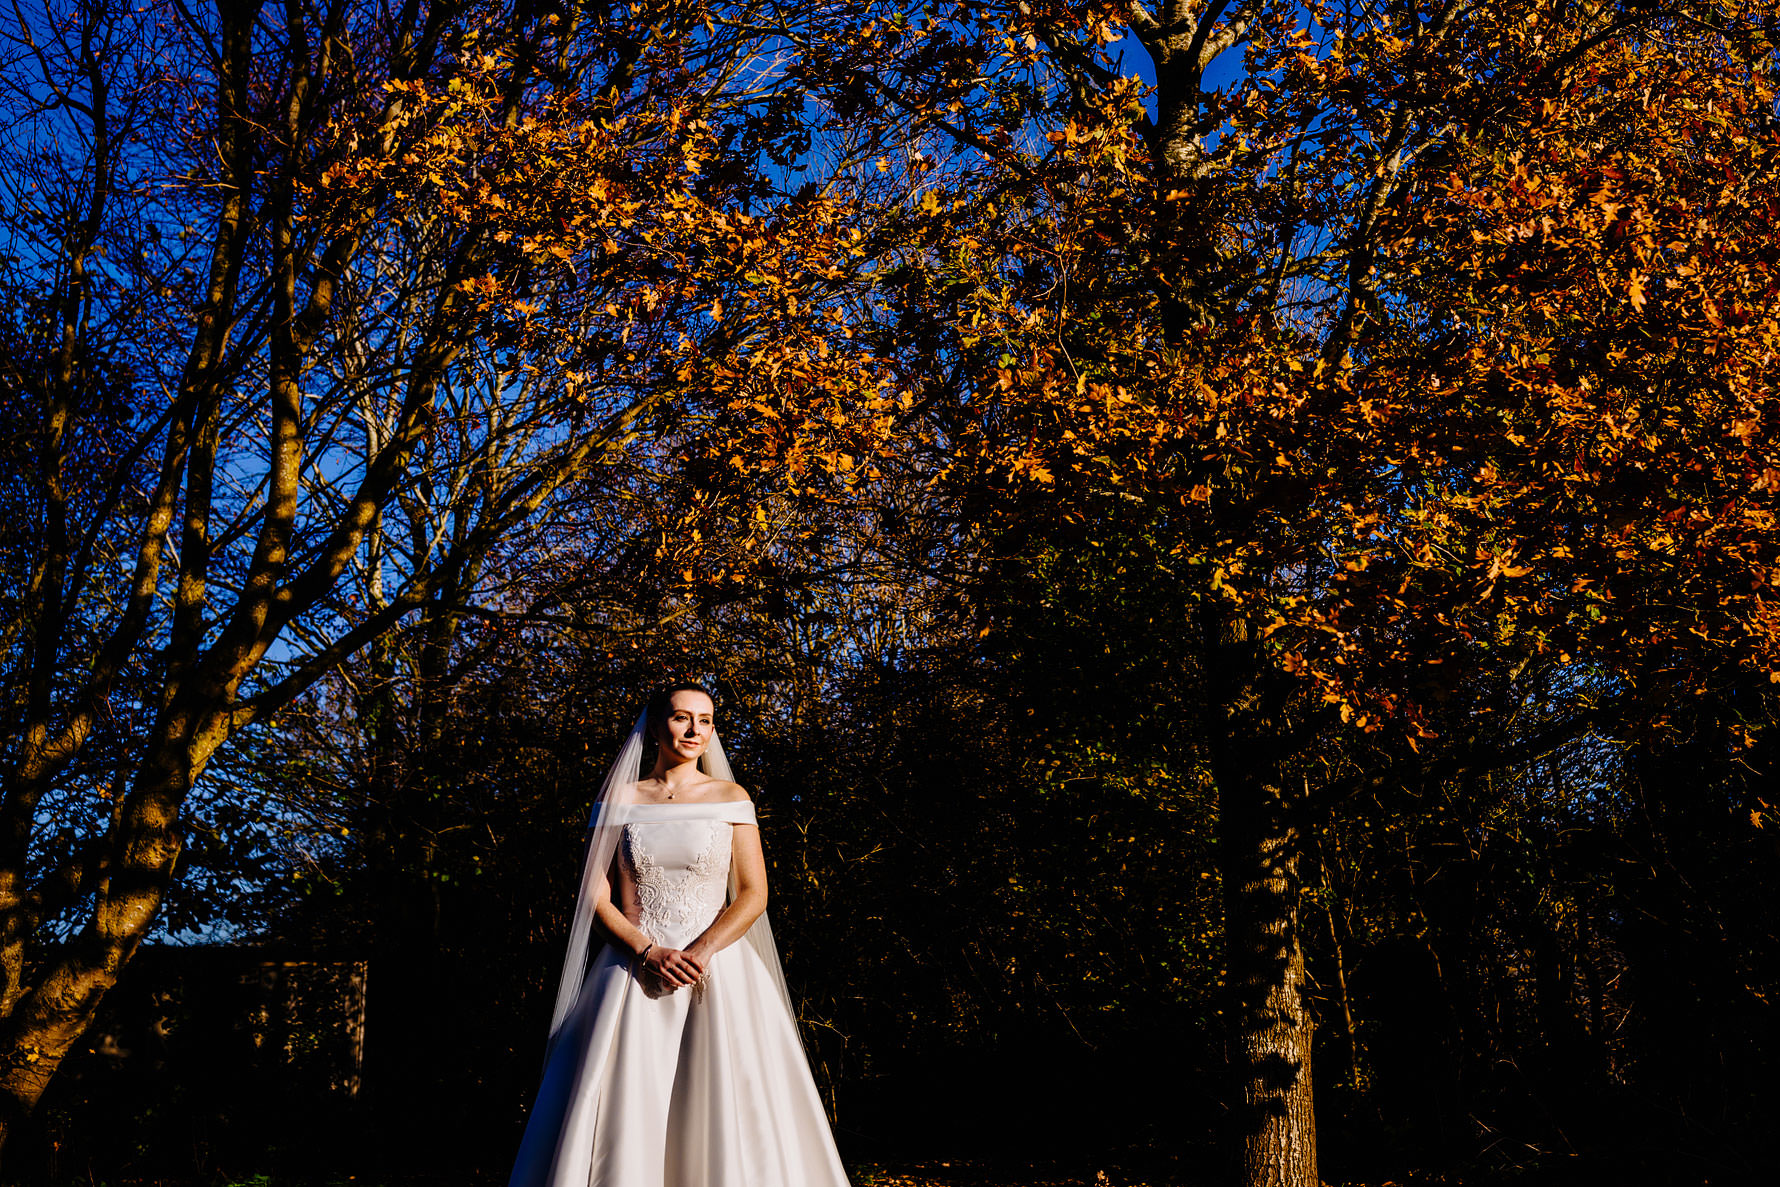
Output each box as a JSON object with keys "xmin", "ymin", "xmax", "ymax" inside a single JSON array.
[{"xmin": 9, "ymin": 594, "xmax": 1780, "ymax": 1183}]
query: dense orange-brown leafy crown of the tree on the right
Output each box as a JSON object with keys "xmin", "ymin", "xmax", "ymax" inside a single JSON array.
[{"xmin": 886, "ymin": 5, "xmax": 1780, "ymax": 737}]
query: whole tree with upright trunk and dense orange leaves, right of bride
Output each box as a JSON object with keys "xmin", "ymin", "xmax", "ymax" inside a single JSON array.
[{"xmin": 847, "ymin": 4, "xmax": 1780, "ymax": 1183}]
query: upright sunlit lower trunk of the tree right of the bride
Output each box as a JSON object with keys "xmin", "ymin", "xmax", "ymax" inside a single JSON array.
[{"xmin": 1205, "ymin": 616, "xmax": 1321, "ymax": 1187}]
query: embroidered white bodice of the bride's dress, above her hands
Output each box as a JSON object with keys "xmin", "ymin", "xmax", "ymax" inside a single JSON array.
[{"xmin": 619, "ymin": 819, "xmax": 733, "ymax": 949}]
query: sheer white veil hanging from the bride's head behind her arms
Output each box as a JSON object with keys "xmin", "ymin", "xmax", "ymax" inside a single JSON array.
[{"xmin": 545, "ymin": 708, "xmax": 797, "ymax": 1064}]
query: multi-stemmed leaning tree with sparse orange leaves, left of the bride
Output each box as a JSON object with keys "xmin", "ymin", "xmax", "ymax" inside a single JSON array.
[{"xmin": 0, "ymin": 0, "xmax": 918, "ymax": 1141}]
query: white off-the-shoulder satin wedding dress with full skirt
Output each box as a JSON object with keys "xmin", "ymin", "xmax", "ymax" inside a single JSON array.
[{"xmin": 507, "ymin": 801, "xmax": 847, "ymax": 1187}]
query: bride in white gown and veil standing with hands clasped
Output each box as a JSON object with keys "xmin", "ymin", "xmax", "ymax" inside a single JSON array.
[{"xmin": 507, "ymin": 683, "xmax": 847, "ymax": 1187}]
